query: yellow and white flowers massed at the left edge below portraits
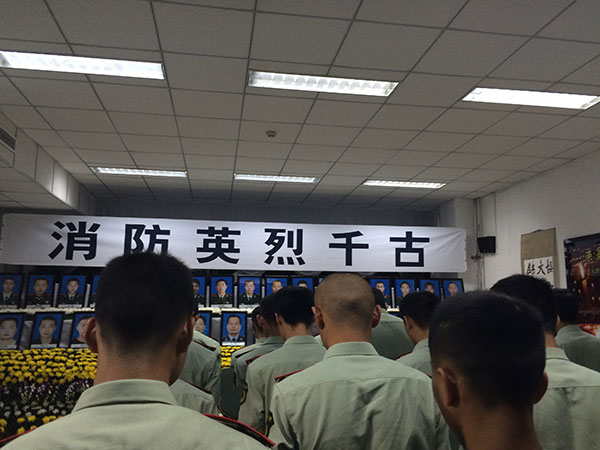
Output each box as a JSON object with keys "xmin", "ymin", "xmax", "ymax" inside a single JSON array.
[{"xmin": 0, "ymin": 348, "xmax": 96, "ymax": 439}]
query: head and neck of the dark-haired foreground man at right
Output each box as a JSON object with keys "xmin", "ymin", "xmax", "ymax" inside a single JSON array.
[{"xmin": 426, "ymin": 292, "xmax": 548, "ymax": 450}]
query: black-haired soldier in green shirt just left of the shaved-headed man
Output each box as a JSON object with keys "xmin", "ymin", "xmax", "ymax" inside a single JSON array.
[{"xmin": 239, "ymin": 287, "xmax": 325, "ymax": 433}]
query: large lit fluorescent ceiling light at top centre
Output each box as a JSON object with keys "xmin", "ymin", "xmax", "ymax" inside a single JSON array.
[{"xmin": 248, "ymin": 71, "xmax": 398, "ymax": 97}]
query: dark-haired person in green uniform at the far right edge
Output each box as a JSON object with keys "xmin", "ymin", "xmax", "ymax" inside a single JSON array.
[{"xmin": 554, "ymin": 289, "xmax": 600, "ymax": 372}]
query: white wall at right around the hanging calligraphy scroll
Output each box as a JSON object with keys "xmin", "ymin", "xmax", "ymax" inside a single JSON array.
[{"xmin": 480, "ymin": 150, "xmax": 600, "ymax": 288}]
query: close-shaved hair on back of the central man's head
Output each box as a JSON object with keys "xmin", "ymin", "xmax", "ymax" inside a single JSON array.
[{"xmin": 315, "ymin": 273, "xmax": 375, "ymax": 329}]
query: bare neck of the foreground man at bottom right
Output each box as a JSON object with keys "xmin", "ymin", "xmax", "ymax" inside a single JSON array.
[{"xmin": 462, "ymin": 407, "xmax": 542, "ymax": 450}]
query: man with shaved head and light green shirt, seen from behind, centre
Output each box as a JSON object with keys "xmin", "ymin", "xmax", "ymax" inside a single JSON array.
[{"xmin": 269, "ymin": 274, "xmax": 449, "ymax": 450}]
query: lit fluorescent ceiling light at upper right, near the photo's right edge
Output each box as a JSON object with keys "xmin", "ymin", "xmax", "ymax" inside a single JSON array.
[{"xmin": 463, "ymin": 88, "xmax": 600, "ymax": 109}]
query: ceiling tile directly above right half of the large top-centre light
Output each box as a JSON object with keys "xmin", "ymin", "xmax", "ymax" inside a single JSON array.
[{"xmin": 336, "ymin": 22, "xmax": 440, "ymax": 70}]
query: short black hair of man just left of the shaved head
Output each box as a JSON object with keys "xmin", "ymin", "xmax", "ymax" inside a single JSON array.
[{"xmin": 273, "ymin": 286, "xmax": 315, "ymax": 327}]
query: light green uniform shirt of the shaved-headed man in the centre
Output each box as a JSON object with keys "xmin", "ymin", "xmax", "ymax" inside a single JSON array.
[{"xmin": 269, "ymin": 342, "xmax": 449, "ymax": 450}]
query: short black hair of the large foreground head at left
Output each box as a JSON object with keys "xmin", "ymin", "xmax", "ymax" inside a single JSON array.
[{"xmin": 96, "ymin": 252, "xmax": 194, "ymax": 354}]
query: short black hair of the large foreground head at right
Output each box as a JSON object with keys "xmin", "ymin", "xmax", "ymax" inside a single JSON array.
[{"xmin": 429, "ymin": 291, "xmax": 546, "ymax": 409}]
